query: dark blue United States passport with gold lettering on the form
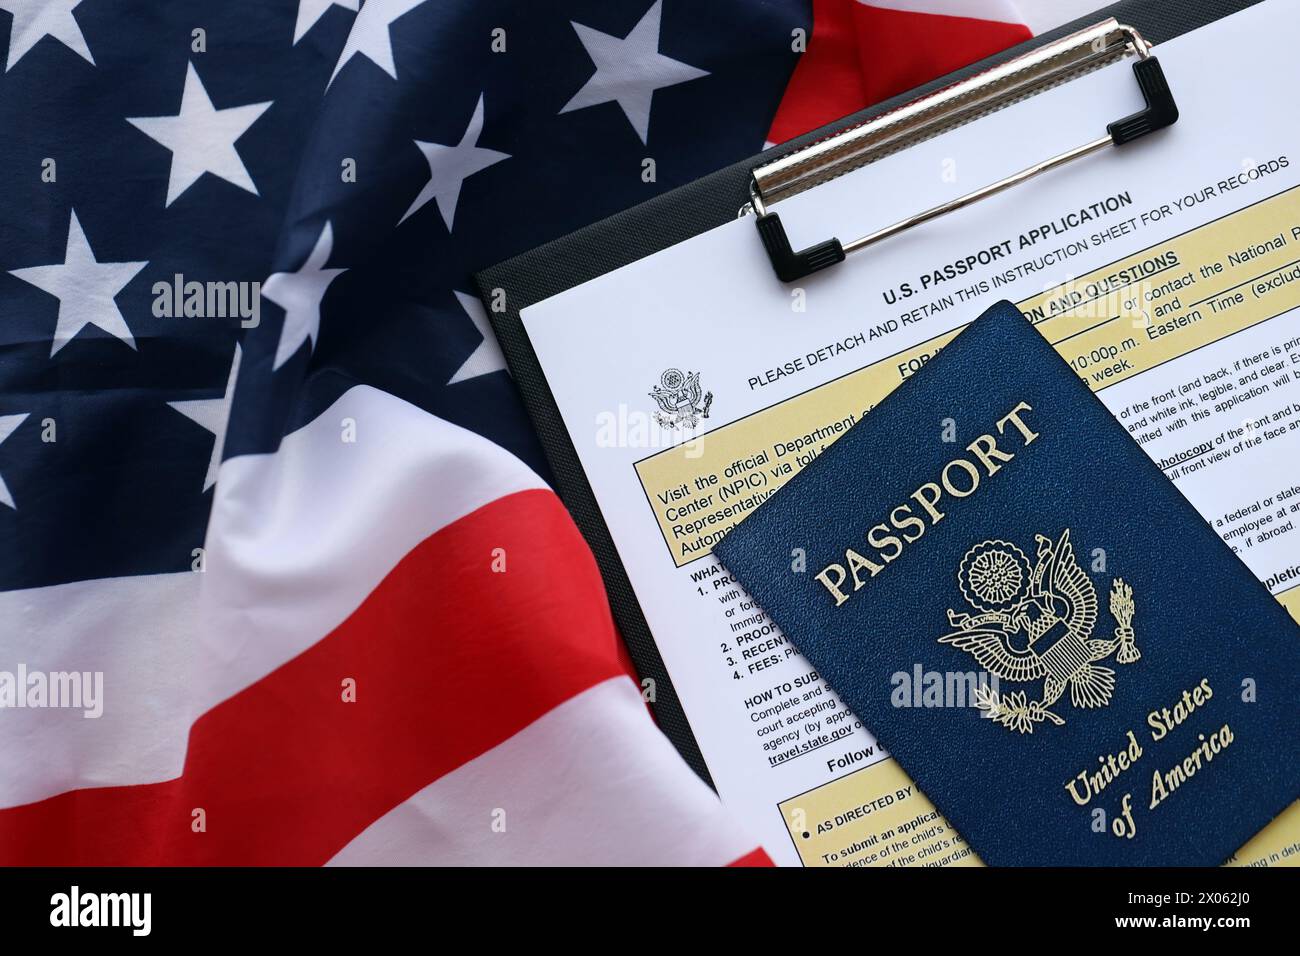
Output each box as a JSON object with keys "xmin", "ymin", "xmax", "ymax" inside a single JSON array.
[{"xmin": 715, "ymin": 302, "xmax": 1300, "ymax": 866}]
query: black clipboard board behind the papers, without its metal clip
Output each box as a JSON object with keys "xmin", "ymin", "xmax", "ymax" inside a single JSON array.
[{"xmin": 475, "ymin": 0, "xmax": 1261, "ymax": 786}]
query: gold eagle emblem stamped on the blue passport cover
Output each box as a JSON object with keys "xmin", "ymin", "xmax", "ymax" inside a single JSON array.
[{"xmin": 939, "ymin": 528, "xmax": 1141, "ymax": 734}]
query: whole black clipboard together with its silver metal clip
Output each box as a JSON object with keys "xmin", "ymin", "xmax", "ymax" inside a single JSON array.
[{"xmin": 475, "ymin": 0, "xmax": 1260, "ymax": 786}]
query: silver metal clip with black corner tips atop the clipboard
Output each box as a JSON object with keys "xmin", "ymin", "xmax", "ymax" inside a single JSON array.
[{"xmin": 741, "ymin": 18, "xmax": 1178, "ymax": 282}]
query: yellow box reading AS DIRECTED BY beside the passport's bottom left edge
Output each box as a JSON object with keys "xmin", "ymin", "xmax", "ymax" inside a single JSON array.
[{"xmin": 780, "ymin": 758, "xmax": 984, "ymax": 866}]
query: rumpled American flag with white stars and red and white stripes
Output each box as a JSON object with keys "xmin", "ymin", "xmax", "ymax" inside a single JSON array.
[{"xmin": 0, "ymin": 0, "xmax": 1088, "ymax": 865}]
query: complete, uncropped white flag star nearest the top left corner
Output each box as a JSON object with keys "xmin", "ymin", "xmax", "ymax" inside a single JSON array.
[{"xmin": 126, "ymin": 62, "xmax": 270, "ymax": 206}]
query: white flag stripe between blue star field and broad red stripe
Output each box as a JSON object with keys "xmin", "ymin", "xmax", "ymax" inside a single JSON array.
[{"xmin": 0, "ymin": 386, "xmax": 546, "ymax": 806}]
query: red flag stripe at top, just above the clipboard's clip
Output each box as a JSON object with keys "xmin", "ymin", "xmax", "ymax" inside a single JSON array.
[{"xmin": 767, "ymin": 0, "xmax": 1032, "ymax": 143}]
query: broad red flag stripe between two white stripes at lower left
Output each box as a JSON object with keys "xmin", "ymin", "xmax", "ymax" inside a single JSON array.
[{"xmin": 0, "ymin": 490, "xmax": 624, "ymax": 865}]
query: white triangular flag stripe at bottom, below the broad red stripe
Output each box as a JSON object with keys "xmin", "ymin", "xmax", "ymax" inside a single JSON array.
[{"xmin": 329, "ymin": 678, "xmax": 755, "ymax": 866}]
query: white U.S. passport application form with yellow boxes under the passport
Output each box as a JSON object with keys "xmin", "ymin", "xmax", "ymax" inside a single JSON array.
[{"xmin": 523, "ymin": 0, "xmax": 1300, "ymax": 866}]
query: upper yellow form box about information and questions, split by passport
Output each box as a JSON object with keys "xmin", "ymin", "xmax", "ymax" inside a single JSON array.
[{"xmin": 636, "ymin": 187, "xmax": 1300, "ymax": 567}]
